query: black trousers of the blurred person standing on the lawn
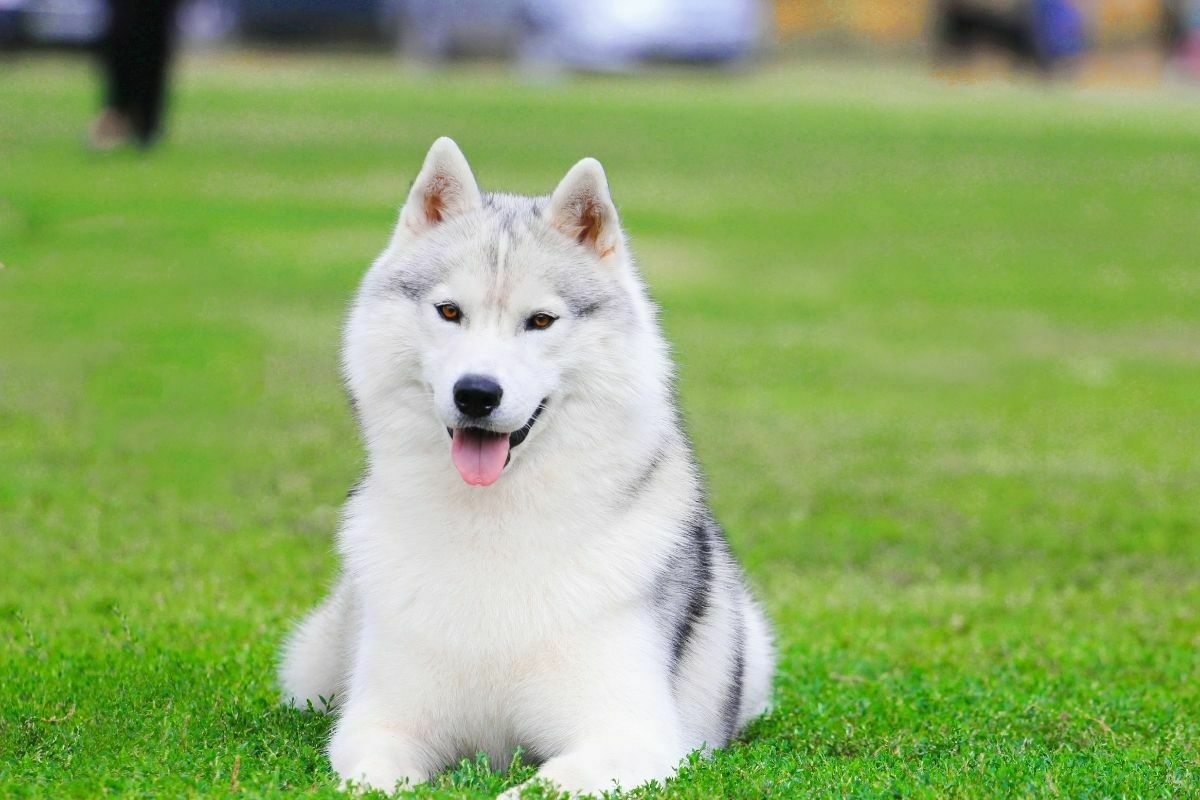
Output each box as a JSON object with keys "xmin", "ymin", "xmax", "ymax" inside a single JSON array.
[{"xmin": 103, "ymin": 0, "xmax": 179, "ymax": 145}]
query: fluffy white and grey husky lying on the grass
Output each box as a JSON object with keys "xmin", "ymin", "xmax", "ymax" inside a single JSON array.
[{"xmin": 281, "ymin": 138, "xmax": 774, "ymax": 793}]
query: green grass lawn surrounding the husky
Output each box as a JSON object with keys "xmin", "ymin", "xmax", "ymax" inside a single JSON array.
[{"xmin": 0, "ymin": 56, "xmax": 1200, "ymax": 798}]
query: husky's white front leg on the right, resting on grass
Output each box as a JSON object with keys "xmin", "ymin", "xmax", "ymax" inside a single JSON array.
[{"xmin": 502, "ymin": 613, "xmax": 688, "ymax": 799}]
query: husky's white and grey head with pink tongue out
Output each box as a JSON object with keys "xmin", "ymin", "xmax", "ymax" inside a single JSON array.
[{"xmin": 343, "ymin": 138, "xmax": 659, "ymax": 486}]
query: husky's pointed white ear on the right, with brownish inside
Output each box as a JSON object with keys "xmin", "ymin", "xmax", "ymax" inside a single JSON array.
[{"xmin": 545, "ymin": 158, "xmax": 623, "ymax": 259}]
